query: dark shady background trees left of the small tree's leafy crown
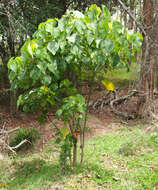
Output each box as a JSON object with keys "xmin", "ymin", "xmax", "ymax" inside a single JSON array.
[{"xmin": 0, "ymin": 0, "xmax": 67, "ymax": 114}]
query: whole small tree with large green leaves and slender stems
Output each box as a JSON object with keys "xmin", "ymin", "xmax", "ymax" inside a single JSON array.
[{"xmin": 8, "ymin": 4, "xmax": 142, "ymax": 164}]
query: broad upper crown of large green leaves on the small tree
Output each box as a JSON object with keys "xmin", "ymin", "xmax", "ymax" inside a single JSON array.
[{"xmin": 8, "ymin": 5, "xmax": 142, "ymax": 113}]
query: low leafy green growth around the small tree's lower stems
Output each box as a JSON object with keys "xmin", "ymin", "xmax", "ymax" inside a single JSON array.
[{"xmin": 56, "ymin": 94, "xmax": 86, "ymax": 169}]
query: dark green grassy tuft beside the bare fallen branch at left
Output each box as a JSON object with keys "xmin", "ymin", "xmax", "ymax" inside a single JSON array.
[{"xmin": 9, "ymin": 127, "xmax": 39, "ymax": 150}]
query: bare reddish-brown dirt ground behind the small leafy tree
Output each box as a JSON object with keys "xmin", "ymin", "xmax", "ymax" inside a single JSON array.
[{"xmin": 0, "ymin": 89, "xmax": 143, "ymax": 150}]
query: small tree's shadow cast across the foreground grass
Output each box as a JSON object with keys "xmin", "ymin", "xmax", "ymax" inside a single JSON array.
[{"xmin": 6, "ymin": 159, "xmax": 113, "ymax": 190}]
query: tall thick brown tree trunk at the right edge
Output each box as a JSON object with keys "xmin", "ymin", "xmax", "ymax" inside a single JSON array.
[{"xmin": 138, "ymin": 0, "xmax": 158, "ymax": 116}]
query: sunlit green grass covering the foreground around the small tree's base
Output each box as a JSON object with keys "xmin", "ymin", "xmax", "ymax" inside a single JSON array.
[{"xmin": 0, "ymin": 126, "xmax": 158, "ymax": 190}]
